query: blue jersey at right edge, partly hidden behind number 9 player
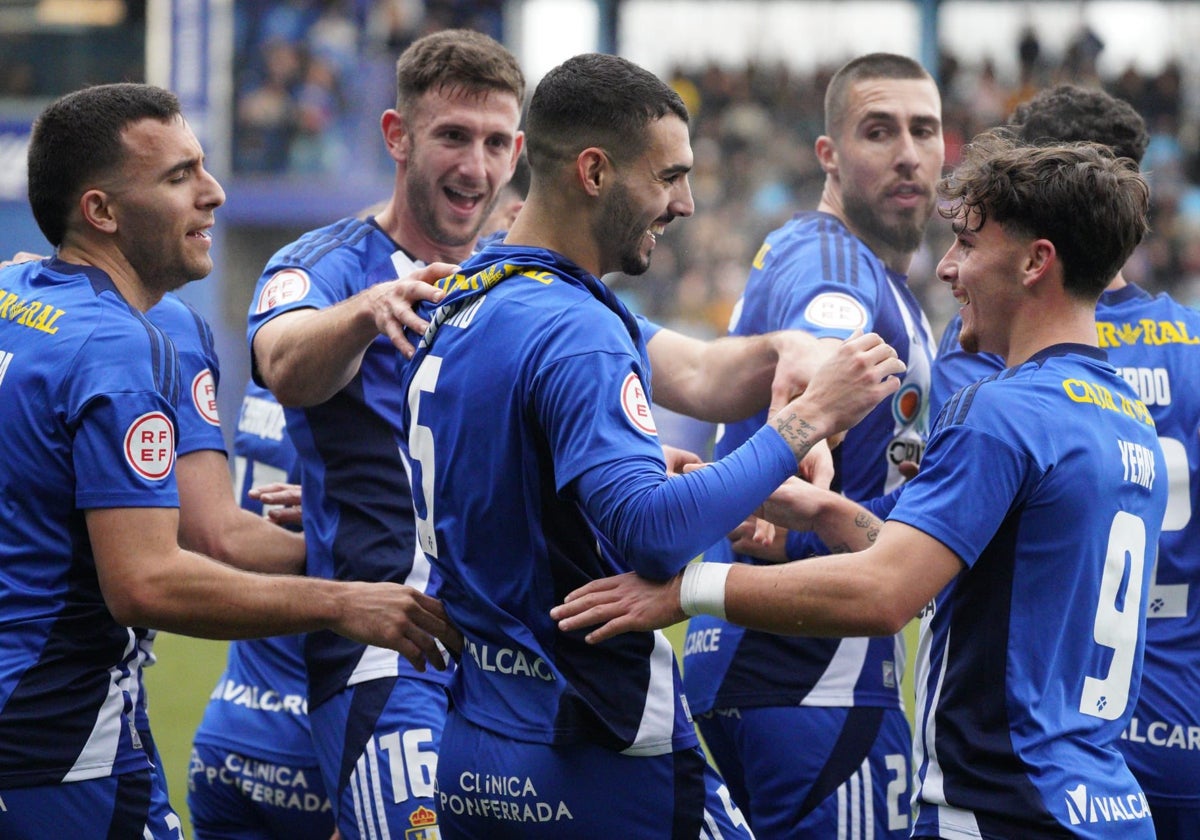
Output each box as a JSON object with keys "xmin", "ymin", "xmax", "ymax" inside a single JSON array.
[{"xmin": 932, "ymin": 284, "xmax": 1200, "ymax": 808}]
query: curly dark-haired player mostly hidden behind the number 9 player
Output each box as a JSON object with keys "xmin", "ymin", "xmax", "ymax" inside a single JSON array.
[{"xmin": 932, "ymin": 85, "xmax": 1200, "ymax": 840}]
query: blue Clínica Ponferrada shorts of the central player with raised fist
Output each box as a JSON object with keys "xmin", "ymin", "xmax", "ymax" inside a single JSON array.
[{"xmin": 438, "ymin": 710, "xmax": 754, "ymax": 840}]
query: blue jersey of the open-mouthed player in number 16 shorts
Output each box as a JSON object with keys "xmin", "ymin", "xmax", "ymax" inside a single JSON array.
[{"xmin": 248, "ymin": 218, "xmax": 448, "ymax": 707}]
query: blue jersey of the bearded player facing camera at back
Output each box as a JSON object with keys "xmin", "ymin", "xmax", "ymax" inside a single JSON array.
[{"xmin": 684, "ymin": 212, "xmax": 934, "ymax": 713}]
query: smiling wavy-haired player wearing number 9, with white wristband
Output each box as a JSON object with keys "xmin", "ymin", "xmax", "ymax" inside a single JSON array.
[{"xmin": 554, "ymin": 136, "xmax": 1168, "ymax": 840}]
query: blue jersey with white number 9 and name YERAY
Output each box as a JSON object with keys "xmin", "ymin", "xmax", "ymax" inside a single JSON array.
[{"xmin": 889, "ymin": 344, "xmax": 1168, "ymax": 838}]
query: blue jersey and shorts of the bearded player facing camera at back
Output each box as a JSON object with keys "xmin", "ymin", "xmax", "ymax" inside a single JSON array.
[{"xmin": 684, "ymin": 212, "xmax": 934, "ymax": 838}]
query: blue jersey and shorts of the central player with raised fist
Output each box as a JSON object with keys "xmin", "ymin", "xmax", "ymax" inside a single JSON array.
[{"xmin": 402, "ymin": 246, "xmax": 811, "ymax": 838}]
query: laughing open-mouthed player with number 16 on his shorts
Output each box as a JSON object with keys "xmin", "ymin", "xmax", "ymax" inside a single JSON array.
[{"xmin": 248, "ymin": 30, "xmax": 524, "ymax": 840}]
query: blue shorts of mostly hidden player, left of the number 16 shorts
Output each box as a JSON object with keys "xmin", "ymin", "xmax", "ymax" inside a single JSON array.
[{"xmin": 187, "ymin": 744, "xmax": 334, "ymax": 840}]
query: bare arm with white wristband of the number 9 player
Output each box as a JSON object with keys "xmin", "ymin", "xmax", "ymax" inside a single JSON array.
[{"xmin": 551, "ymin": 522, "xmax": 962, "ymax": 642}]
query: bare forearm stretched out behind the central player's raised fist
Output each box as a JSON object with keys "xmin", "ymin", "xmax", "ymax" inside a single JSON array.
[{"xmin": 647, "ymin": 328, "xmax": 840, "ymax": 422}]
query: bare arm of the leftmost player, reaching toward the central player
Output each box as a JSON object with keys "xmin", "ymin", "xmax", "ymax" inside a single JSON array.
[{"xmin": 85, "ymin": 508, "xmax": 462, "ymax": 670}]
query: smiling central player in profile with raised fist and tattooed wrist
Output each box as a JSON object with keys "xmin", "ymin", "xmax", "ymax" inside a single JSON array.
[{"xmin": 401, "ymin": 55, "xmax": 902, "ymax": 840}]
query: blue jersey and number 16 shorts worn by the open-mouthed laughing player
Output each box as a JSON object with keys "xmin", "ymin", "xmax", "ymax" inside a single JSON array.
[{"xmin": 248, "ymin": 218, "xmax": 448, "ymax": 840}]
